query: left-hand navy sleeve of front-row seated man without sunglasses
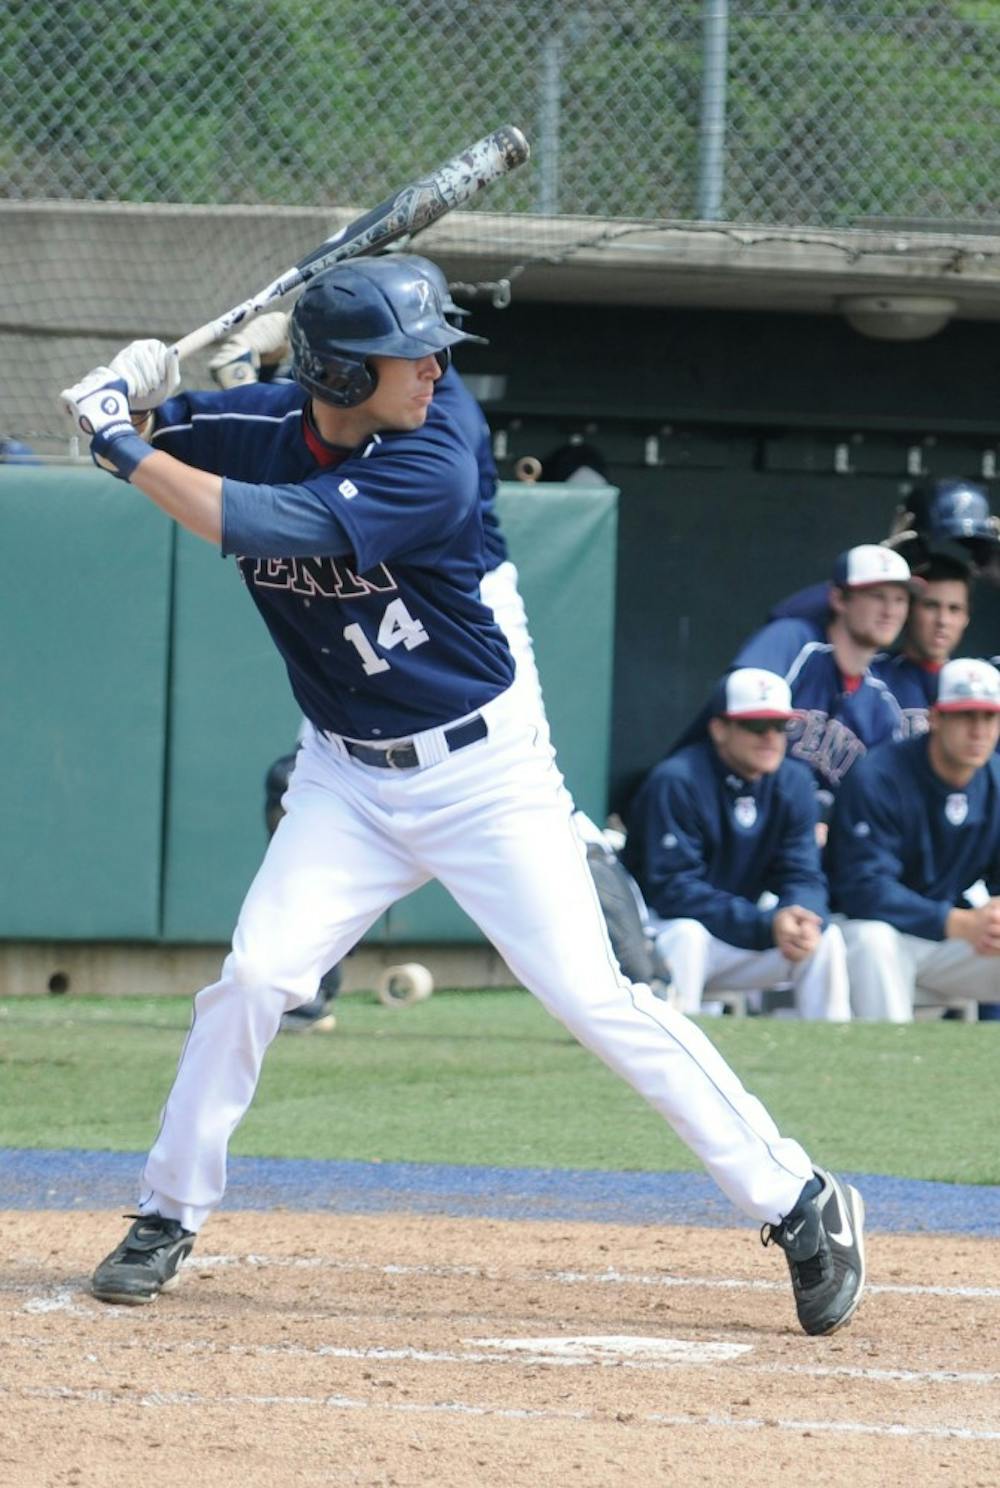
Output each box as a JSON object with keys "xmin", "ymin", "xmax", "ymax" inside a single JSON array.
[{"xmin": 826, "ymin": 751, "xmax": 954, "ymax": 940}]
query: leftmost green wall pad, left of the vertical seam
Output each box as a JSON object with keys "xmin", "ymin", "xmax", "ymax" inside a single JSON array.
[{"xmin": 0, "ymin": 466, "xmax": 174, "ymax": 940}]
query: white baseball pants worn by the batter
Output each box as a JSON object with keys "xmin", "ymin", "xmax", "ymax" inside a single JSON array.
[{"xmin": 140, "ymin": 687, "xmax": 813, "ymax": 1231}]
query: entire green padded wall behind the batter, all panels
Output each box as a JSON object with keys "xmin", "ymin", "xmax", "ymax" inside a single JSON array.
[{"xmin": 0, "ymin": 467, "xmax": 618, "ymax": 942}]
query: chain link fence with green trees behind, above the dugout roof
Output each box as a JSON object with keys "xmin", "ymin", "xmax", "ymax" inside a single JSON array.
[{"xmin": 0, "ymin": 0, "xmax": 1000, "ymax": 226}]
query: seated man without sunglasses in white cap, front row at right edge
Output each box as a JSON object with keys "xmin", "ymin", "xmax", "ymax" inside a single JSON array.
[{"xmin": 826, "ymin": 659, "xmax": 1000, "ymax": 1022}]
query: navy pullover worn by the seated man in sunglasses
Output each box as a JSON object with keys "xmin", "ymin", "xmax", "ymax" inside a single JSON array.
[{"xmin": 624, "ymin": 741, "xmax": 827, "ymax": 951}]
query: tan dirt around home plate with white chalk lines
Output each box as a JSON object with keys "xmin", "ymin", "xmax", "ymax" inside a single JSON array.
[{"xmin": 0, "ymin": 1211, "xmax": 1000, "ymax": 1488}]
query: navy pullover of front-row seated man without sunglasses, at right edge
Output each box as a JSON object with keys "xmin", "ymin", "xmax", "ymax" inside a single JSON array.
[{"xmin": 824, "ymin": 735, "xmax": 1000, "ymax": 940}]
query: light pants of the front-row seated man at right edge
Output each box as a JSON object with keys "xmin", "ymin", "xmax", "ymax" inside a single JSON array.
[{"xmin": 841, "ymin": 920, "xmax": 1000, "ymax": 1022}]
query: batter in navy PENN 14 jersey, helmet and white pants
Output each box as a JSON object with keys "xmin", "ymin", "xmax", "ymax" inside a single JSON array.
[{"xmin": 63, "ymin": 254, "xmax": 865, "ymax": 1333}]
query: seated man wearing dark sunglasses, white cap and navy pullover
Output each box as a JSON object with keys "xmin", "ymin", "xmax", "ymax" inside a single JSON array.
[{"xmin": 625, "ymin": 667, "xmax": 850, "ymax": 1021}]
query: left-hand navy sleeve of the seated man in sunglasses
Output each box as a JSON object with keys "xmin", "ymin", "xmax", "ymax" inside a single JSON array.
[{"xmin": 635, "ymin": 772, "xmax": 774, "ymax": 951}]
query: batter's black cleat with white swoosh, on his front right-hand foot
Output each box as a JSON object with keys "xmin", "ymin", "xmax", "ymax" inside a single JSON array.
[{"xmin": 760, "ymin": 1168, "xmax": 865, "ymax": 1333}]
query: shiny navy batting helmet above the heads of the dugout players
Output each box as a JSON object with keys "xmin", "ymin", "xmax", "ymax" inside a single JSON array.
[{"xmin": 885, "ymin": 476, "xmax": 1000, "ymax": 568}]
